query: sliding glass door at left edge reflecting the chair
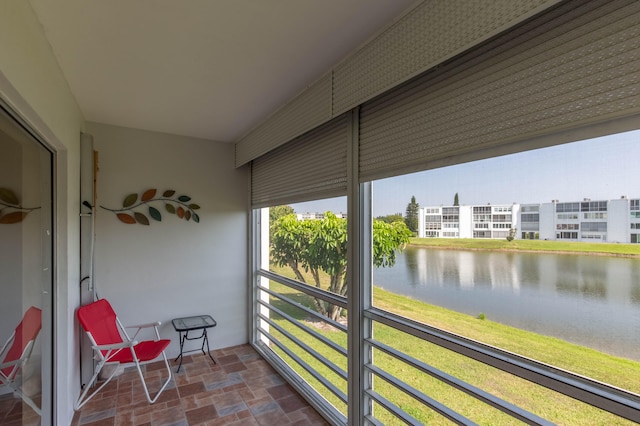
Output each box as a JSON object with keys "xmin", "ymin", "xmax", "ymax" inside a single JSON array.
[{"xmin": 0, "ymin": 107, "xmax": 53, "ymax": 425}]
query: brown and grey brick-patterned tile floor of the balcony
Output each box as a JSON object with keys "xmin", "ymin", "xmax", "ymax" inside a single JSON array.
[{"xmin": 62, "ymin": 345, "xmax": 328, "ymax": 426}]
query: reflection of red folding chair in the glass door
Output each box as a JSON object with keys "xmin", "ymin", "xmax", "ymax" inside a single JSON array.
[{"xmin": 0, "ymin": 306, "xmax": 42, "ymax": 415}]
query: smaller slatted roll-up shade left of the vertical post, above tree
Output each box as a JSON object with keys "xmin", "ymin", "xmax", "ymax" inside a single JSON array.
[{"xmin": 251, "ymin": 114, "xmax": 348, "ymax": 208}]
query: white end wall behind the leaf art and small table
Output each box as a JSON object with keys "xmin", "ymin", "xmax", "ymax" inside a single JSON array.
[{"xmin": 87, "ymin": 123, "xmax": 248, "ymax": 356}]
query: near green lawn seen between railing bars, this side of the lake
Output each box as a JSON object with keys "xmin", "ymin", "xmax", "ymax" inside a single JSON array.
[{"xmin": 264, "ymin": 264, "xmax": 640, "ymax": 425}]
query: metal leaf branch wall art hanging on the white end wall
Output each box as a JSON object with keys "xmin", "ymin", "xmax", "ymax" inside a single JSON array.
[{"xmin": 100, "ymin": 189, "xmax": 200, "ymax": 225}]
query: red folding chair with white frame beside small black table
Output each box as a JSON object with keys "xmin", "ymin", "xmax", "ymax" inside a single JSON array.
[{"xmin": 75, "ymin": 299, "xmax": 171, "ymax": 410}]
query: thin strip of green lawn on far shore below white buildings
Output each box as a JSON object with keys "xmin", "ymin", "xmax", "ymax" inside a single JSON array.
[{"xmin": 410, "ymin": 238, "xmax": 640, "ymax": 257}]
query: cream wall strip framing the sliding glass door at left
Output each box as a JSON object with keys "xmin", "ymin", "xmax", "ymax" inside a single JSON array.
[{"xmin": 0, "ymin": 0, "xmax": 84, "ymax": 425}]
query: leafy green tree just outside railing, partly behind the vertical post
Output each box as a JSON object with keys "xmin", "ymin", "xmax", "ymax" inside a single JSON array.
[{"xmin": 270, "ymin": 212, "xmax": 411, "ymax": 320}]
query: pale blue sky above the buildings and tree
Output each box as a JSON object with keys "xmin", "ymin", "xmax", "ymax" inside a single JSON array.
[{"xmin": 292, "ymin": 130, "xmax": 640, "ymax": 217}]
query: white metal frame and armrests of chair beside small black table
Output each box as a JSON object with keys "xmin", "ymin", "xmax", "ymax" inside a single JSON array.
[{"xmin": 74, "ymin": 310, "xmax": 172, "ymax": 410}]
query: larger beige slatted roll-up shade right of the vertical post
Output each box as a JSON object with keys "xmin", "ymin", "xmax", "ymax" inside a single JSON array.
[{"xmin": 359, "ymin": 0, "xmax": 640, "ymax": 182}]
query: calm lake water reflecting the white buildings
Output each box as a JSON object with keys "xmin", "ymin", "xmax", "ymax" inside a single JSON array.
[{"xmin": 373, "ymin": 247, "xmax": 640, "ymax": 360}]
